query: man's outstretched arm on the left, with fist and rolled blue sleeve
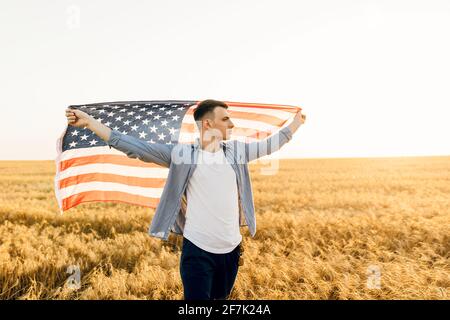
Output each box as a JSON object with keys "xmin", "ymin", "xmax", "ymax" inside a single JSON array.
[{"xmin": 66, "ymin": 108, "xmax": 173, "ymax": 167}]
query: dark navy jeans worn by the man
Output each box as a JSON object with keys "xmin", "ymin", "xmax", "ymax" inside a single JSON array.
[{"xmin": 180, "ymin": 237, "xmax": 241, "ymax": 300}]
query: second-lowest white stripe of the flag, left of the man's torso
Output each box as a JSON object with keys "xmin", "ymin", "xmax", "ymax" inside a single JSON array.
[{"xmin": 59, "ymin": 163, "xmax": 169, "ymax": 180}]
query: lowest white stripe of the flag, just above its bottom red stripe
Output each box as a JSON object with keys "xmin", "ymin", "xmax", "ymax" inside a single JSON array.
[{"xmin": 60, "ymin": 182, "xmax": 163, "ymax": 199}]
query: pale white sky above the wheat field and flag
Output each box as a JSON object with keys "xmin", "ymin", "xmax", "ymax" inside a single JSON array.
[{"xmin": 0, "ymin": 0, "xmax": 450, "ymax": 160}]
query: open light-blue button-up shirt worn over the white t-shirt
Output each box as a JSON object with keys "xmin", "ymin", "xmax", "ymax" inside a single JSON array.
[{"xmin": 106, "ymin": 126, "xmax": 292, "ymax": 240}]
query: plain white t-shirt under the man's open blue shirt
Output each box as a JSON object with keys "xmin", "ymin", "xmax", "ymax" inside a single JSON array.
[{"xmin": 183, "ymin": 148, "xmax": 242, "ymax": 253}]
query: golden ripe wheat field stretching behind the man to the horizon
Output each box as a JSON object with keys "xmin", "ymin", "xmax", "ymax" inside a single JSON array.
[{"xmin": 0, "ymin": 157, "xmax": 450, "ymax": 300}]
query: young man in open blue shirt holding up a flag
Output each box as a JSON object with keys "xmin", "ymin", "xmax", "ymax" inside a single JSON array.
[{"xmin": 66, "ymin": 99, "xmax": 306, "ymax": 300}]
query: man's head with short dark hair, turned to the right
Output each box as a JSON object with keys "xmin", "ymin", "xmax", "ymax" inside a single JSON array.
[{"xmin": 194, "ymin": 99, "xmax": 234, "ymax": 140}]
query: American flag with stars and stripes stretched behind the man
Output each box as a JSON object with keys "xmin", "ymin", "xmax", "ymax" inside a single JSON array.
[{"xmin": 55, "ymin": 100, "xmax": 300, "ymax": 213}]
